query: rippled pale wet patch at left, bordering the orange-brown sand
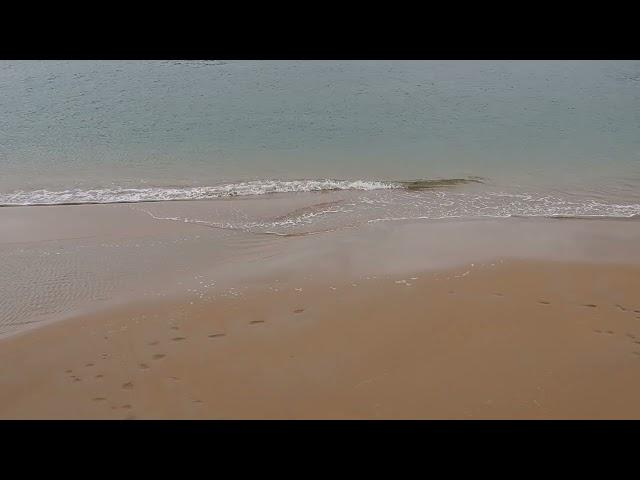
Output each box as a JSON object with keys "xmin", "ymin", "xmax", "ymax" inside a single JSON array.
[{"xmin": 0, "ymin": 230, "xmax": 272, "ymax": 336}]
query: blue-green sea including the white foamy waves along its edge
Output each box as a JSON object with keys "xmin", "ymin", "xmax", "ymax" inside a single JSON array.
[{"xmin": 0, "ymin": 60, "xmax": 640, "ymax": 234}]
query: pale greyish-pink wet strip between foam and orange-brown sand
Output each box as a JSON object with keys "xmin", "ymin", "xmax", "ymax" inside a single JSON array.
[{"xmin": 0, "ymin": 199, "xmax": 640, "ymax": 338}]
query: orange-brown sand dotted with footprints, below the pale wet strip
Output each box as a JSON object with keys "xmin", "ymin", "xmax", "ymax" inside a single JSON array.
[{"xmin": 0, "ymin": 260, "xmax": 640, "ymax": 419}]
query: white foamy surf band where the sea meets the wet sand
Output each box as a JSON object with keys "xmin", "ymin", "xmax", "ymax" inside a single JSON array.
[{"xmin": 0, "ymin": 179, "xmax": 640, "ymax": 236}]
